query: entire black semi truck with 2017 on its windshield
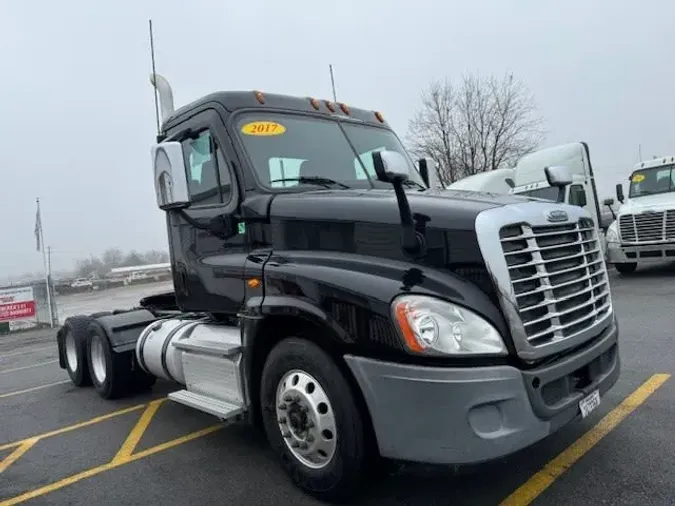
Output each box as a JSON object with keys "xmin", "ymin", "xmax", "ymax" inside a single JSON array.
[{"xmin": 57, "ymin": 74, "xmax": 620, "ymax": 500}]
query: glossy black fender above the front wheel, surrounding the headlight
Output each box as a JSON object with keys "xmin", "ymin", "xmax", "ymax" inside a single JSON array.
[{"xmin": 243, "ymin": 251, "xmax": 510, "ymax": 355}]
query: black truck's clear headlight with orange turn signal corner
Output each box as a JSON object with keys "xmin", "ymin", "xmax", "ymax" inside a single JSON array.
[{"xmin": 392, "ymin": 295, "xmax": 508, "ymax": 356}]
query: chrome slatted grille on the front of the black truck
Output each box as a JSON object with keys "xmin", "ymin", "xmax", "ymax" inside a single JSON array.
[{"xmin": 499, "ymin": 218, "xmax": 611, "ymax": 347}]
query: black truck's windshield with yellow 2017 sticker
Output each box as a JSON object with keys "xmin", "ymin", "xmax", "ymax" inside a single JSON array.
[{"xmin": 237, "ymin": 112, "xmax": 424, "ymax": 188}]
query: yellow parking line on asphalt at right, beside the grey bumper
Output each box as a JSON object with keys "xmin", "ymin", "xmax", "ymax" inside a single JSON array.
[{"xmin": 500, "ymin": 374, "xmax": 670, "ymax": 506}]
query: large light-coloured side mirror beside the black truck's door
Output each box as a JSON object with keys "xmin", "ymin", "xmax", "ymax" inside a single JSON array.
[{"xmin": 150, "ymin": 142, "xmax": 190, "ymax": 211}]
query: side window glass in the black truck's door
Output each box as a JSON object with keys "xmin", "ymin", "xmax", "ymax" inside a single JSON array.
[{"xmin": 183, "ymin": 130, "xmax": 232, "ymax": 205}]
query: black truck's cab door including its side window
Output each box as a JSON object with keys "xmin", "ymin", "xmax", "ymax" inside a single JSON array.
[{"xmin": 167, "ymin": 109, "xmax": 248, "ymax": 314}]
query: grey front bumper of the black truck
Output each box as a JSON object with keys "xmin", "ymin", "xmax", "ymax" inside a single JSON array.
[{"xmin": 345, "ymin": 319, "xmax": 620, "ymax": 464}]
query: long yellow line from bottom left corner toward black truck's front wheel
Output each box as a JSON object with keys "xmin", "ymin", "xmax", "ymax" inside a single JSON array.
[{"xmin": 0, "ymin": 424, "xmax": 223, "ymax": 506}]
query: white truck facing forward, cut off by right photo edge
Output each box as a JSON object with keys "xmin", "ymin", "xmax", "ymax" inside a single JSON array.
[{"xmin": 605, "ymin": 156, "xmax": 675, "ymax": 274}]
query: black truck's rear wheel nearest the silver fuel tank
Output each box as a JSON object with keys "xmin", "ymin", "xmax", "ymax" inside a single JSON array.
[{"xmin": 87, "ymin": 321, "xmax": 135, "ymax": 399}]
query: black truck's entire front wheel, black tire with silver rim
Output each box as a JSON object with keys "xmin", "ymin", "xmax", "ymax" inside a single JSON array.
[{"xmin": 260, "ymin": 337, "xmax": 369, "ymax": 501}]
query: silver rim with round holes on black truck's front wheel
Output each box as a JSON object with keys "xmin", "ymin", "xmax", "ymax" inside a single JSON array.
[{"xmin": 276, "ymin": 370, "xmax": 337, "ymax": 469}]
